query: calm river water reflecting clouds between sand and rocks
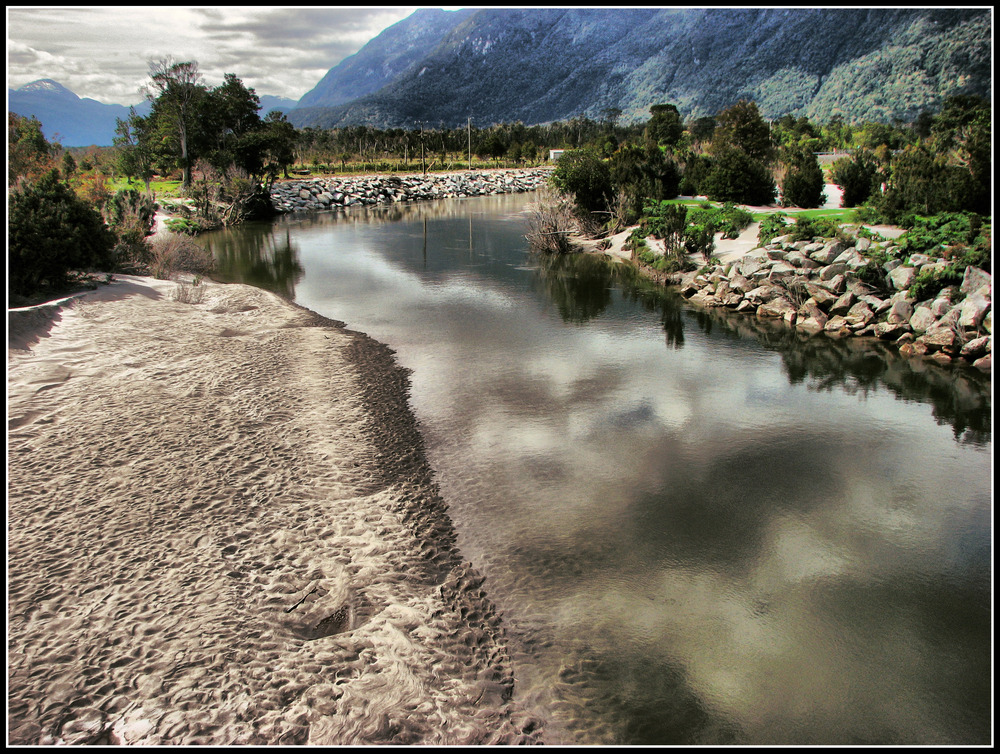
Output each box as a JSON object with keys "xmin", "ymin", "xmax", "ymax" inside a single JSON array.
[{"xmin": 197, "ymin": 195, "xmax": 992, "ymax": 744}]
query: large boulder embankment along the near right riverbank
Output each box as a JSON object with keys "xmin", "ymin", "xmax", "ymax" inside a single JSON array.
[{"xmin": 665, "ymin": 231, "xmax": 993, "ymax": 371}]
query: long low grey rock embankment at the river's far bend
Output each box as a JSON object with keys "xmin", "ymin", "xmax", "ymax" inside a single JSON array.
[{"xmin": 271, "ymin": 168, "xmax": 552, "ymax": 212}]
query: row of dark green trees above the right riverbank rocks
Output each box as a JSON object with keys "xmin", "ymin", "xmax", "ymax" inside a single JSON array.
[{"xmin": 553, "ymin": 96, "xmax": 992, "ymax": 231}]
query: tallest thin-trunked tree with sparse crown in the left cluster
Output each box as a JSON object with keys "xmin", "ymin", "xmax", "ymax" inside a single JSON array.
[{"xmin": 146, "ymin": 58, "xmax": 206, "ymax": 188}]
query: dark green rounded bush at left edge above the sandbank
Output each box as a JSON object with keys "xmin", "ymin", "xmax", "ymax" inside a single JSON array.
[{"xmin": 7, "ymin": 170, "xmax": 116, "ymax": 295}]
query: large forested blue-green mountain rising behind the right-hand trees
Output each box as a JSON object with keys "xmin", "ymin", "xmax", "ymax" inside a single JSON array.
[{"xmin": 288, "ymin": 8, "xmax": 992, "ymax": 128}]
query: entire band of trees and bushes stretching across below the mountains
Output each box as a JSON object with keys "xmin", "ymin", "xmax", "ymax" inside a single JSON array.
[{"xmin": 8, "ymin": 68, "xmax": 992, "ymax": 300}]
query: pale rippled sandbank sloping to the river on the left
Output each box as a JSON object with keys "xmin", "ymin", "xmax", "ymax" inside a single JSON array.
[{"xmin": 7, "ymin": 277, "xmax": 539, "ymax": 744}]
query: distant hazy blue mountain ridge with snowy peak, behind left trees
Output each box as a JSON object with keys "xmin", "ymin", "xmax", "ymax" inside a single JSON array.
[{"xmin": 7, "ymin": 79, "xmax": 295, "ymax": 147}]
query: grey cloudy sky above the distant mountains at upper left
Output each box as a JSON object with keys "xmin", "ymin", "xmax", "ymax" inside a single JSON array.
[{"xmin": 7, "ymin": 6, "xmax": 416, "ymax": 105}]
